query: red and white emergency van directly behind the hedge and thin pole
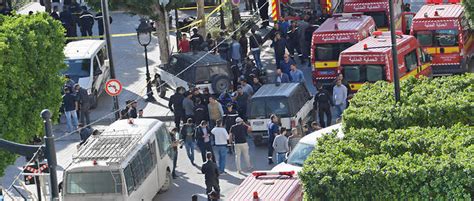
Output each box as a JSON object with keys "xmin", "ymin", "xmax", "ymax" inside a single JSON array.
[{"xmin": 339, "ymin": 31, "xmax": 431, "ymax": 92}]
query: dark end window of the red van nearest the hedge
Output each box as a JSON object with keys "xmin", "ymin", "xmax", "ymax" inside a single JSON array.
[{"xmin": 343, "ymin": 65, "xmax": 384, "ymax": 82}]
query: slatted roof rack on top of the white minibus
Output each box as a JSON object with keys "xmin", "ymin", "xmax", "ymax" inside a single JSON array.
[{"xmin": 72, "ymin": 130, "xmax": 141, "ymax": 164}]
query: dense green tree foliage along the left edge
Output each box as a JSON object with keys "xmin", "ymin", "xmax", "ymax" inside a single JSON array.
[{"xmin": 0, "ymin": 13, "xmax": 65, "ymax": 175}]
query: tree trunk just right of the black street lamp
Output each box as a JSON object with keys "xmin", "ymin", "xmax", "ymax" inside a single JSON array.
[{"xmin": 153, "ymin": 4, "xmax": 170, "ymax": 64}]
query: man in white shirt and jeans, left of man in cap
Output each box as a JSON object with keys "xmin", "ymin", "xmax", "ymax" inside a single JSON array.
[{"xmin": 211, "ymin": 119, "xmax": 229, "ymax": 174}]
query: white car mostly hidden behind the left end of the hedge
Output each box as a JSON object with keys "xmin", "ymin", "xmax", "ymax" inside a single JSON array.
[{"xmin": 272, "ymin": 123, "xmax": 344, "ymax": 172}]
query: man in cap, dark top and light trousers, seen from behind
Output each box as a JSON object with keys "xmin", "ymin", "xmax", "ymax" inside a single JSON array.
[{"xmin": 229, "ymin": 117, "xmax": 252, "ymax": 174}]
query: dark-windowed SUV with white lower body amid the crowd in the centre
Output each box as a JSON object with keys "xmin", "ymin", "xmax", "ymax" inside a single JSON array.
[{"xmin": 248, "ymin": 83, "xmax": 314, "ymax": 144}]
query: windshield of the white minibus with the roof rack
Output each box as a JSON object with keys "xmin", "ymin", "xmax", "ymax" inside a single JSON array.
[{"xmin": 66, "ymin": 171, "xmax": 122, "ymax": 194}]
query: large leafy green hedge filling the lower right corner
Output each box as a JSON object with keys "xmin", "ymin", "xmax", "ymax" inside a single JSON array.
[{"xmin": 300, "ymin": 74, "xmax": 474, "ymax": 200}]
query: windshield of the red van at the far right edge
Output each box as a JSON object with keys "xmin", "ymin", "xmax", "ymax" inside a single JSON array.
[{"xmin": 416, "ymin": 30, "xmax": 459, "ymax": 47}]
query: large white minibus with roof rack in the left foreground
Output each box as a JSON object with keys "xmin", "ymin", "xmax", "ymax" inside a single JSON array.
[{"xmin": 61, "ymin": 119, "xmax": 176, "ymax": 201}]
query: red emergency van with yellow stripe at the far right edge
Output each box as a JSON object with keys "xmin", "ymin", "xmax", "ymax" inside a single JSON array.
[{"xmin": 411, "ymin": 4, "xmax": 474, "ymax": 76}]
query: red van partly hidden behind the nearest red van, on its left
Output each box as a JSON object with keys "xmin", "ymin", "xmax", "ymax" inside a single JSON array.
[{"xmin": 311, "ymin": 13, "xmax": 375, "ymax": 85}]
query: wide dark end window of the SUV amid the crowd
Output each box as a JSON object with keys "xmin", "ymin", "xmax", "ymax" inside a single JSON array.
[{"xmin": 250, "ymin": 97, "xmax": 290, "ymax": 119}]
